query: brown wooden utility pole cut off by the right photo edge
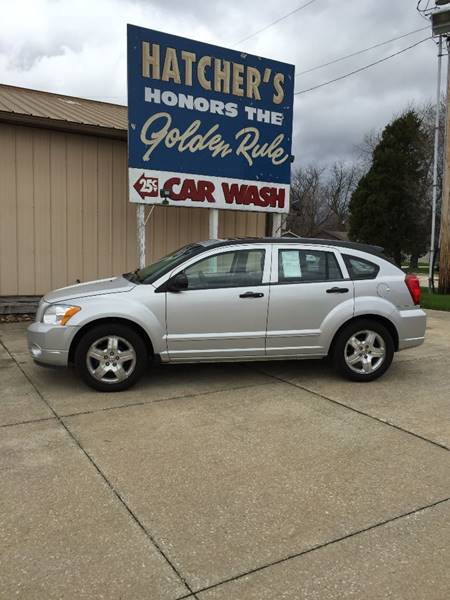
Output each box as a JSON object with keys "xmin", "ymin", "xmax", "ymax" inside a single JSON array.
[{"xmin": 439, "ymin": 37, "xmax": 450, "ymax": 294}]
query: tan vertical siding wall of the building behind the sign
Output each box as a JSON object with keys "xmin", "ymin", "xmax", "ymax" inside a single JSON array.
[{"xmin": 0, "ymin": 124, "xmax": 265, "ymax": 295}]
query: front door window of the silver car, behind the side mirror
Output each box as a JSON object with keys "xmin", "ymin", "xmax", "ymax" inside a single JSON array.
[{"xmin": 184, "ymin": 249, "xmax": 265, "ymax": 290}]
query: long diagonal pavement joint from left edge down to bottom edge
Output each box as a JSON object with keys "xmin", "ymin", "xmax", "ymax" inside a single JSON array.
[{"xmin": 0, "ymin": 340, "xmax": 198, "ymax": 600}]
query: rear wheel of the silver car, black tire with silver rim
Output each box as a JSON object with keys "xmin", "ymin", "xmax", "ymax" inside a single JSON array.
[{"xmin": 333, "ymin": 319, "xmax": 394, "ymax": 381}]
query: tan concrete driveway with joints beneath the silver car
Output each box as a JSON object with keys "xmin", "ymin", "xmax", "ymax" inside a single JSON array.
[{"xmin": 0, "ymin": 312, "xmax": 450, "ymax": 600}]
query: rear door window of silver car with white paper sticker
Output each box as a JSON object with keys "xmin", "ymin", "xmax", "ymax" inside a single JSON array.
[{"xmin": 278, "ymin": 248, "xmax": 343, "ymax": 283}]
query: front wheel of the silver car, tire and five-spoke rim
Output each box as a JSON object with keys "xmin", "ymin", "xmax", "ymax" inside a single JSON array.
[{"xmin": 75, "ymin": 323, "xmax": 149, "ymax": 392}]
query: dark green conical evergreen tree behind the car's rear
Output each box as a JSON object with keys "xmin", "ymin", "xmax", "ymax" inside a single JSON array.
[{"xmin": 349, "ymin": 110, "xmax": 429, "ymax": 265}]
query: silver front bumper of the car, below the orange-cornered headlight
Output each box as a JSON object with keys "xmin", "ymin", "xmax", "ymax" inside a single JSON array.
[{"xmin": 27, "ymin": 323, "xmax": 79, "ymax": 367}]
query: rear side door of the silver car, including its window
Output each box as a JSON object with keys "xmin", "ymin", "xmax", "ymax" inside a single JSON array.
[{"xmin": 266, "ymin": 244, "xmax": 354, "ymax": 357}]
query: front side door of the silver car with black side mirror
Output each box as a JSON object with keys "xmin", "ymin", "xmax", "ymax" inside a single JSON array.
[{"xmin": 166, "ymin": 245, "xmax": 271, "ymax": 361}]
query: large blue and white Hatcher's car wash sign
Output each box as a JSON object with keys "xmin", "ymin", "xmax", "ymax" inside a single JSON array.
[{"xmin": 128, "ymin": 25, "xmax": 294, "ymax": 213}]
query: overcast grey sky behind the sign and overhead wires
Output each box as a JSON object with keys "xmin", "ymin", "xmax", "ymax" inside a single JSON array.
[{"xmin": 0, "ymin": 0, "xmax": 436, "ymax": 165}]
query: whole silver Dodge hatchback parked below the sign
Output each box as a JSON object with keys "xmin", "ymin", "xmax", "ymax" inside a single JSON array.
[{"xmin": 28, "ymin": 238, "xmax": 426, "ymax": 391}]
